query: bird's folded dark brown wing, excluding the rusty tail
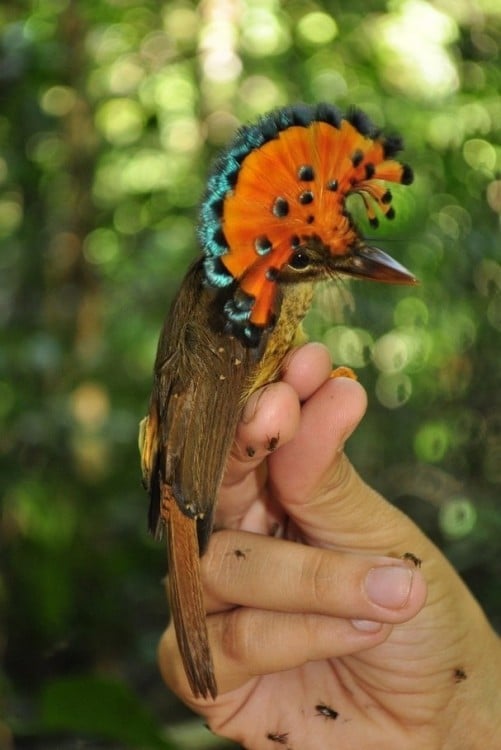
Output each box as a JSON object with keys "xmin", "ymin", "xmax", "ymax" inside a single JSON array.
[{"xmin": 142, "ymin": 261, "xmax": 254, "ymax": 552}]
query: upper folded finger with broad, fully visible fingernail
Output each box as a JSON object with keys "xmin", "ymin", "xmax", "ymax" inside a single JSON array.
[{"xmin": 202, "ymin": 531, "xmax": 426, "ymax": 623}]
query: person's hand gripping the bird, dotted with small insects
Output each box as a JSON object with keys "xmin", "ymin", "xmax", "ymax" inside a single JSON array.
[{"xmin": 159, "ymin": 344, "xmax": 501, "ymax": 750}]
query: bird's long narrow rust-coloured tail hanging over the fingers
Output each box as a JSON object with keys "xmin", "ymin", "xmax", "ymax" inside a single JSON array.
[{"xmin": 167, "ymin": 502, "xmax": 217, "ymax": 699}]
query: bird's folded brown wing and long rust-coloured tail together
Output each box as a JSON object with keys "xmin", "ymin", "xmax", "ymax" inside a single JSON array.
[{"xmin": 139, "ymin": 262, "xmax": 254, "ymax": 697}]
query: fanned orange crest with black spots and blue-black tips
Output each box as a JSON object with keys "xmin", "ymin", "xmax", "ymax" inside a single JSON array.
[{"xmin": 199, "ymin": 104, "xmax": 412, "ymax": 345}]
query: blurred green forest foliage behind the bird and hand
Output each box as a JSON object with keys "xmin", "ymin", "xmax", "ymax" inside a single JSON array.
[{"xmin": 0, "ymin": 0, "xmax": 501, "ymax": 749}]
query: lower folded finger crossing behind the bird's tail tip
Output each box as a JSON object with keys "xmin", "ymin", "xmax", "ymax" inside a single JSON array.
[{"xmin": 159, "ymin": 608, "xmax": 391, "ymax": 704}]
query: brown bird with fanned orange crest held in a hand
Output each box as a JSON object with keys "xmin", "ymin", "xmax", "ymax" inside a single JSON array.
[{"xmin": 139, "ymin": 103, "xmax": 417, "ymax": 699}]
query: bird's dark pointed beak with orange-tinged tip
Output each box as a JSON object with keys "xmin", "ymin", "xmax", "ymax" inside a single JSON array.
[{"xmin": 336, "ymin": 245, "xmax": 419, "ymax": 285}]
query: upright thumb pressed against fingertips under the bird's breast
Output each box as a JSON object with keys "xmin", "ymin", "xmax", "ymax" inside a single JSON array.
[{"xmin": 269, "ymin": 378, "xmax": 421, "ymax": 554}]
